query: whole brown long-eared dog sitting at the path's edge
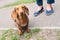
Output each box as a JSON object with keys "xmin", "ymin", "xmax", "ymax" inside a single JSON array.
[{"xmin": 11, "ymin": 5, "xmax": 29, "ymax": 34}]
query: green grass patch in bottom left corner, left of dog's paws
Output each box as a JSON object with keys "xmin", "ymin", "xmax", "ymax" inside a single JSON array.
[{"xmin": 0, "ymin": 29, "xmax": 20, "ymax": 40}]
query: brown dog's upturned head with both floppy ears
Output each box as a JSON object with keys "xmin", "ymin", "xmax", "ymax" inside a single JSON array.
[{"xmin": 12, "ymin": 5, "xmax": 29, "ymax": 22}]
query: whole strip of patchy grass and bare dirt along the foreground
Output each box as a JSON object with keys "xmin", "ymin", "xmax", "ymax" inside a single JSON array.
[{"xmin": 0, "ymin": 28, "xmax": 60, "ymax": 40}]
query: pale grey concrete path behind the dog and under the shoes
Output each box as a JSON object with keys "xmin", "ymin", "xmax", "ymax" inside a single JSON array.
[{"xmin": 0, "ymin": 0, "xmax": 60, "ymax": 28}]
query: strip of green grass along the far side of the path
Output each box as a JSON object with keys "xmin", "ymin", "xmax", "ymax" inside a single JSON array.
[{"xmin": 0, "ymin": 0, "xmax": 36, "ymax": 9}]
